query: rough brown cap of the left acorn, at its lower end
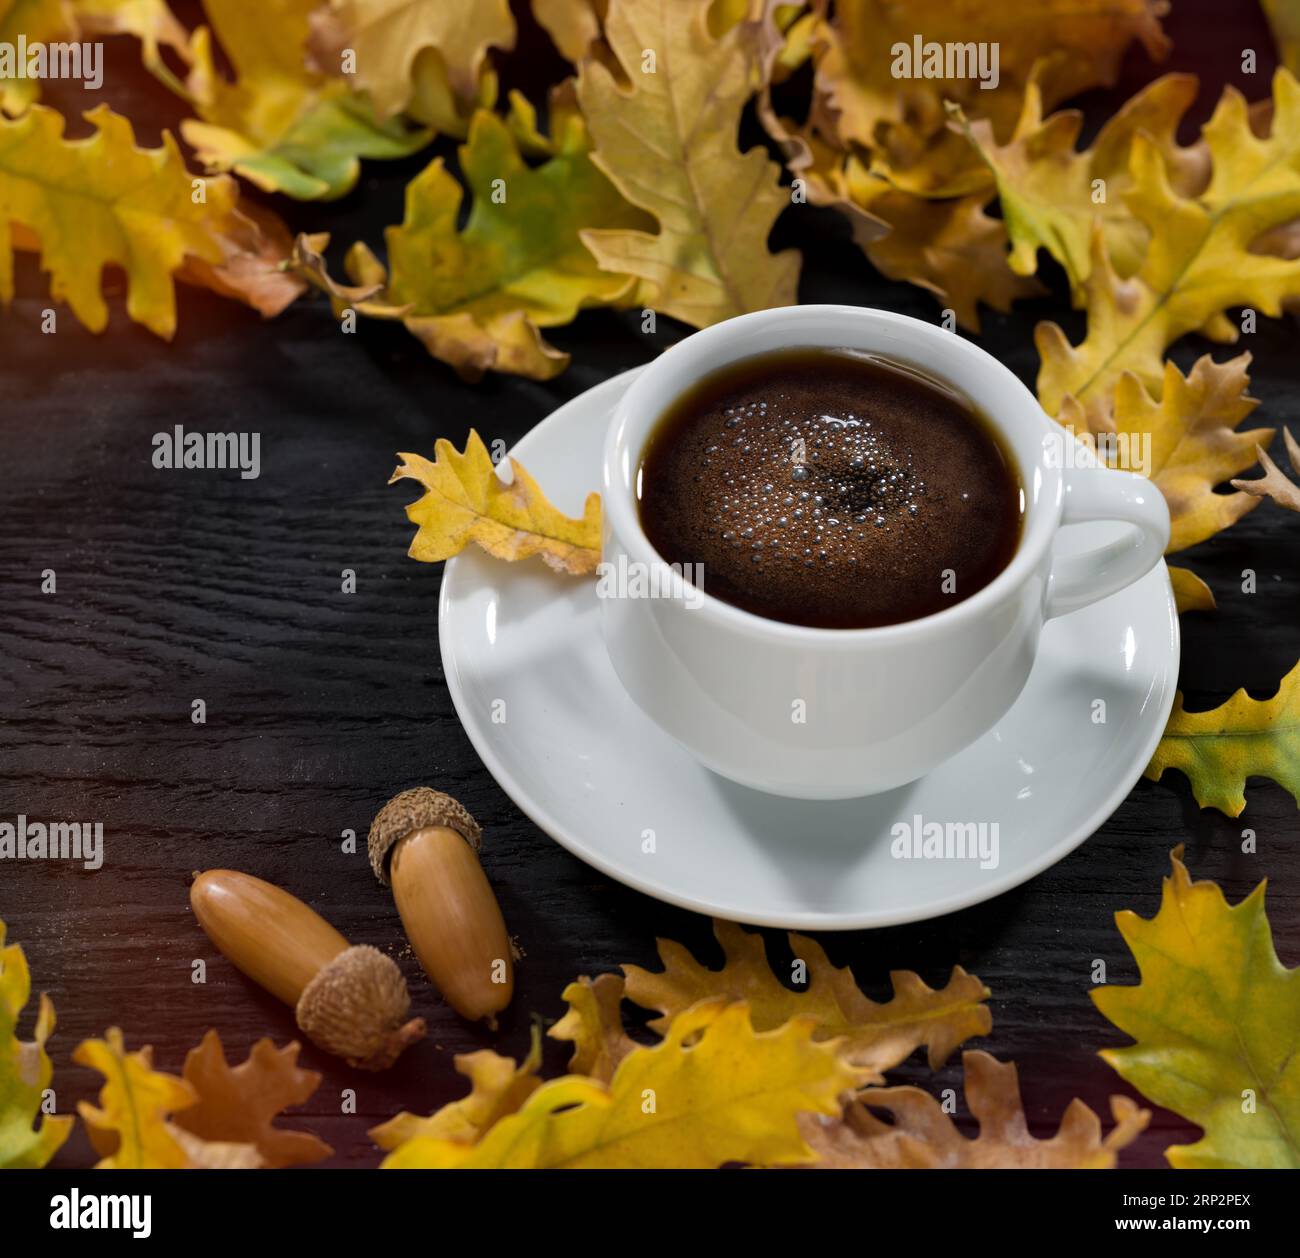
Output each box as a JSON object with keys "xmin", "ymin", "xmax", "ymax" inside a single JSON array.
[{"xmin": 294, "ymin": 945, "xmax": 425, "ymax": 1070}]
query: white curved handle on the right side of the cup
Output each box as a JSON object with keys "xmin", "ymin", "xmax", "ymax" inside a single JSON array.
[{"xmin": 1044, "ymin": 467, "xmax": 1169, "ymax": 620}]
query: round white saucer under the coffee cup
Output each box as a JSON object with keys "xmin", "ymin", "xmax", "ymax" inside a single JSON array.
[{"xmin": 438, "ymin": 372, "xmax": 1178, "ymax": 931}]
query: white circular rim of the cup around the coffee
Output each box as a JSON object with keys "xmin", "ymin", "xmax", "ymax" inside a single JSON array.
[{"xmin": 602, "ymin": 304, "xmax": 1063, "ymax": 648}]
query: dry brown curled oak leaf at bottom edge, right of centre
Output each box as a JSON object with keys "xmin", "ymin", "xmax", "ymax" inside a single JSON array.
[{"xmin": 800, "ymin": 1051, "xmax": 1151, "ymax": 1171}]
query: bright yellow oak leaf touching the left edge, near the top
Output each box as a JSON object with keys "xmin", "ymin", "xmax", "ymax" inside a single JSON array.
[{"xmin": 0, "ymin": 105, "xmax": 238, "ymax": 339}]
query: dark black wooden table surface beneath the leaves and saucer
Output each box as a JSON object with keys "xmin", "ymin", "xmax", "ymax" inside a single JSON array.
[{"xmin": 0, "ymin": 0, "xmax": 1300, "ymax": 1166}]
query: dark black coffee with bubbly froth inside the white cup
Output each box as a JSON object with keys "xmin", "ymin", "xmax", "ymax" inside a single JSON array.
[{"xmin": 640, "ymin": 350, "xmax": 1022, "ymax": 629}]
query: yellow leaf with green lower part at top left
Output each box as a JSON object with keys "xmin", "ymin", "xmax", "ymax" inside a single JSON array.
[{"xmin": 181, "ymin": 0, "xmax": 430, "ymax": 200}]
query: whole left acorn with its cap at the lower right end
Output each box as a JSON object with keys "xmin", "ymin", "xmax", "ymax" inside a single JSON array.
[{"xmin": 190, "ymin": 869, "xmax": 425, "ymax": 1070}]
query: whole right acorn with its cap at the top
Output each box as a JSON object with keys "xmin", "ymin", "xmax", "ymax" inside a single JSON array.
[{"xmin": 369, "ymin": 786, "xmax": 515, "ymax": 1028}]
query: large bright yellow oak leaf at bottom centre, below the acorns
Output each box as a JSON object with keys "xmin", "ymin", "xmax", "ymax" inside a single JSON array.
[{"xmin": 384, "ymin": 1001, "xmax": 863, "ymax": 1170}]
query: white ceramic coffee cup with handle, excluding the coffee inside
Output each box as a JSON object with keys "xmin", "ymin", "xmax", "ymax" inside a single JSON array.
[{"xmin": 601, "ymin": 305, "xmax": 1169, "ymax": 799}]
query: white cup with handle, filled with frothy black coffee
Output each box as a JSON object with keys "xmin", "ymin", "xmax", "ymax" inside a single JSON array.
[{"xmin": 601, "ymin": 305, "xmax": 1169, "ymax": 799}]
